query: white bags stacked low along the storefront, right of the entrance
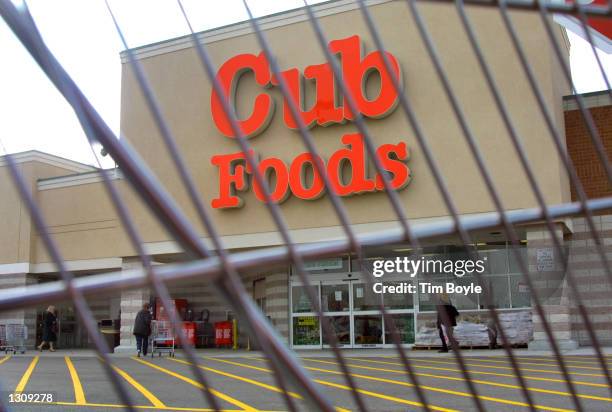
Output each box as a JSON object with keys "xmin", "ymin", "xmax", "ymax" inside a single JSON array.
[{"xmin": 415, "ymin": 311, "xmax": 533, "ymax": 346}]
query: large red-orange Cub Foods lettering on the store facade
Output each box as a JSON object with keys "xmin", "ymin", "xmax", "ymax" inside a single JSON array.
[{"xmin": 211, "ymin": 36, "xmax": 410, "ymax": 209}]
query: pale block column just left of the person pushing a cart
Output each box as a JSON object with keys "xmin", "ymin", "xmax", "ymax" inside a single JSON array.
[{"xmin": 115, "ymin": 258, "xmax": 151, "ymax": 353}]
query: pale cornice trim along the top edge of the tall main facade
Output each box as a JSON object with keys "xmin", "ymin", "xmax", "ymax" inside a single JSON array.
[{"xmin": 120, "ymin": 0, "xmax": 393, "ymax": 63}]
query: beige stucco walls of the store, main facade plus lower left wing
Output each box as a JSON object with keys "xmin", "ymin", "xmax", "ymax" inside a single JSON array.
[{"xmin": 0, "ymin": 2, "xmax": 569, "ymax": 263}]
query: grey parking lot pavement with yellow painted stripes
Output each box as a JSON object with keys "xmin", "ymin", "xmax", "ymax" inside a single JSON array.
[{"xmin": 0, "ymin": 351, "xmax": 612, "ymax": 412}]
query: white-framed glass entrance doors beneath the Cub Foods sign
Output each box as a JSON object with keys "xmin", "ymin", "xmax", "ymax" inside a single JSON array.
[{"xmin": 291, "ymin": 276, "xmax": 415, "ymax": 348}]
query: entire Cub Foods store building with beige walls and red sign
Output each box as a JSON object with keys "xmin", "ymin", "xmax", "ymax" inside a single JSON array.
[{"xmin": 0, "ymin": 1, "xmax": 612, "ymax": 350}]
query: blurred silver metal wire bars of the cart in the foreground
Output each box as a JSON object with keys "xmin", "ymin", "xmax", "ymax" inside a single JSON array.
[{"xmin": 0, "ymin": 0, "xmax": 612, "ymax": 411}]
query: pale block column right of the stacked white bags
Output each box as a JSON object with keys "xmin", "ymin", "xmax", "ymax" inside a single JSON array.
[{"xmin": 527, "ymin": 226, "xmax": 578, "ymax": 350}]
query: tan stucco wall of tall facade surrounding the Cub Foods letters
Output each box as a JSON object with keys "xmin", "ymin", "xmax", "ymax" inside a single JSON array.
[{"xmin": 122, "ymin": 2, "xmax": 565, "ymax": 240}]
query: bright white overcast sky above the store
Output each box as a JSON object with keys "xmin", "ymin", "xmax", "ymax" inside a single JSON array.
[{"xmin": 0, "ymin": 0, "xmax": 612, "ymax": 165}]
